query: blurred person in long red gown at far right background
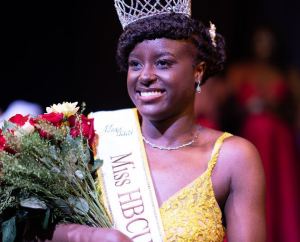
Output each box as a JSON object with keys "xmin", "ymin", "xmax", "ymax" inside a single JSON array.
[{"xmin": 223, "ymin": 27, "xmax": 300, "ymax": 242}]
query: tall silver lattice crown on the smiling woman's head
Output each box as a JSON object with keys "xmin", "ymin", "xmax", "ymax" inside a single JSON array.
[{"xmin": 115, "ymin": 0, "xmax": 191, "ymax": 29}]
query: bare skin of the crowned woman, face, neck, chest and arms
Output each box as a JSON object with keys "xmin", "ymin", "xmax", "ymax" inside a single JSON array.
[{"xmin": 48, "ymin": 39, "xmax": 265, "ymax": 242}]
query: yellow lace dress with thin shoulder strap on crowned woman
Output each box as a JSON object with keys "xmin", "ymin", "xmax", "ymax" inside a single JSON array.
[{"xmin": 160, "ymin": 133, "xmax": 231, "ymax": 242}]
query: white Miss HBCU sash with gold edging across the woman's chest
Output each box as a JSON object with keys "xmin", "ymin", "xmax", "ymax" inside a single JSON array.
[{"xmin": 89, "ymin": 109, "xmax": 164, "ymax": 242}]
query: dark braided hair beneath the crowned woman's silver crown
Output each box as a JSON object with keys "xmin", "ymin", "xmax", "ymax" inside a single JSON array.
[{"xmin": 117, "ymin": 13, "xmax": 226, "ymax": 84}]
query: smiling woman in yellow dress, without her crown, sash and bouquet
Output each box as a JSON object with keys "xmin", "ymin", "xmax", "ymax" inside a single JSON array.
[{"xmin": 48, "ymin": 9, "xmax": 265, "ymax": 242}]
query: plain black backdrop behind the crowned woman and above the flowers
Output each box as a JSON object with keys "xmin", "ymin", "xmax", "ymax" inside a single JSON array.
[{"xmin": 0, "ymin": 0, "xmax": 300, "ymax": 110}]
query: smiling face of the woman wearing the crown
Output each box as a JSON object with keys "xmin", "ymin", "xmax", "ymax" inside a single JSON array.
[{"xmin": 127, "ymin": 38, "xmax": 203, "ymax": 121}]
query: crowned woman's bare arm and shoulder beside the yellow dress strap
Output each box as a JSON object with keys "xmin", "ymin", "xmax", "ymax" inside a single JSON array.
[{"xmin": 225, "ymin": 137, "xmax": 266, "ymax": 242}]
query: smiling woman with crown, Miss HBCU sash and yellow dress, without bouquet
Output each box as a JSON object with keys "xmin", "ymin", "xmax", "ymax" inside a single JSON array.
[{"xmin": 45, "ymin": 0, "xmax": 265, "ymax": 242}]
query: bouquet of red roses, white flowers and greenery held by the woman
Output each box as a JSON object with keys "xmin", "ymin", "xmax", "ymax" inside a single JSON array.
[{"xmin": 0, "ymin": 103, "xmax": 111, "ymax": 242}]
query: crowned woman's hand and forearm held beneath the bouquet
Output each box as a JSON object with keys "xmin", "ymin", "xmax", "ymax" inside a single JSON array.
[{"xmin": 46, "ymin": 224, "xmax": 132, "ymax": 242}]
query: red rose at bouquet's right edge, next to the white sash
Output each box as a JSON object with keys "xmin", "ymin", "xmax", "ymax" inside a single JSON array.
[{"xmin": 68, "ymin": 114, "xmax": 95, "ymax": 145}]
